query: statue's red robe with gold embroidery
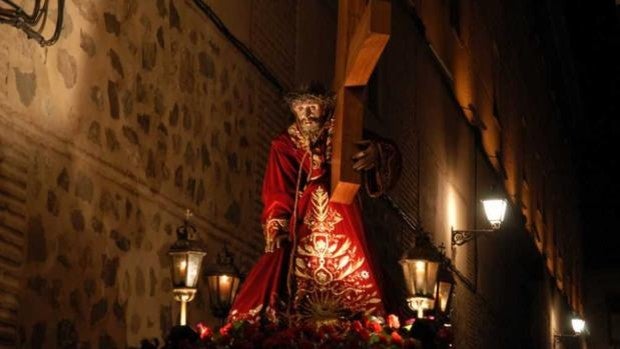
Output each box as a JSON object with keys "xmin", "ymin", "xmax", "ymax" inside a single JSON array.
[{"xmin": 230, "ymin": 133, "xmax": 392, "ymax": 321}]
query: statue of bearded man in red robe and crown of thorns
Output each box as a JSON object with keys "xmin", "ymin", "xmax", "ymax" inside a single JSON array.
[{"xmin": 229, "ymin": 83, "xmax": 400, "ymax": 324}]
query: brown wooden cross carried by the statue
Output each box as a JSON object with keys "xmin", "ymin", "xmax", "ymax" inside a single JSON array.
[{"xmin": 331, "ymin": 0, "xmax": 391, "ymax": 204}]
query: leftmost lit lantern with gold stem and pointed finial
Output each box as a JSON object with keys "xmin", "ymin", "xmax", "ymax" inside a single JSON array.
[{"xmin": 168, "ymin": 210, "xmax": 207, "ymax": 326}]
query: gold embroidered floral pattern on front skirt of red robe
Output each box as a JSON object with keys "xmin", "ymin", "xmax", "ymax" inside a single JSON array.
[{"xmin": 294, "ymin": 186, "xmax": 381, "ymax": 323}]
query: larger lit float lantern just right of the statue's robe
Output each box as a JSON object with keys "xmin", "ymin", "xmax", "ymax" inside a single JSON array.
[{"xmin": 400, "ymin": 233, "xmax": 441, "ymax": 318}]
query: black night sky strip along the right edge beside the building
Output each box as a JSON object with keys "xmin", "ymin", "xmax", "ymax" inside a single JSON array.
[{"xmin": 564, "ymin": 0, "xmax": 620, "ymax": 268}]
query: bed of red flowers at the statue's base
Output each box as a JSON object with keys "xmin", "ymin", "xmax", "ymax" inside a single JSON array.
[{"xmin": 148, "ymin": 315, "xmax": 452, "ymax": 349}]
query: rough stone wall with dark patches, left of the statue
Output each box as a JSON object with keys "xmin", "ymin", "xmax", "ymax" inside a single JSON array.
[{"xmin": 0, "ymin": 0, "xmax": 295, "ymax": 348}]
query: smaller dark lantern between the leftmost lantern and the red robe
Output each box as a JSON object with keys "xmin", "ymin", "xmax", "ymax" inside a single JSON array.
[{"xmin": 205, "ymin": 246, "xmax": 241, "ymax": 321}]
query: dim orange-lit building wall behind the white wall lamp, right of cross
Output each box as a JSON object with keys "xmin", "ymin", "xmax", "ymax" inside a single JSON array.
[{"xmin": 365, "ymin": 0, "xmax": 583, "ymax": 348}]
